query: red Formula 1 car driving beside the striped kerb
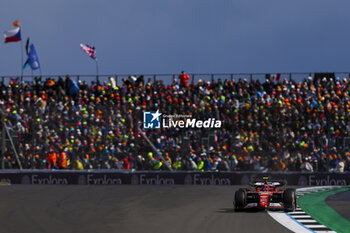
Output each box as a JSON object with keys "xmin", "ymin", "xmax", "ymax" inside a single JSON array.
[{"xmin": 233, "ymin": 177, "xmax": 297, "ymax": 212}]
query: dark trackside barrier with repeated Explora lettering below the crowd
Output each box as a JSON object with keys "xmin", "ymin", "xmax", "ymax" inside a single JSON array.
[{"xmin": 0, "ymin": 170, "xmax": 350, "ymax": 186}]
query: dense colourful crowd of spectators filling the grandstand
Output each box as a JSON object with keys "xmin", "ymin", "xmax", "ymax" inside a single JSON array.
[{"xmin": 0, "ymin": 72, "xmax": 350, "ymax": 172}]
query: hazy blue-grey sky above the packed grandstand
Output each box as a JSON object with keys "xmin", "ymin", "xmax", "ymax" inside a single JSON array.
[{"xmin": 0, "ymin": 0, "xmax": 350, "ymax": 76}]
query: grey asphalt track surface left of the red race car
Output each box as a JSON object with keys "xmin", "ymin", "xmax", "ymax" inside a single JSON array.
[{"xmin": 0, "ymin": 185, "xmax": 290, "ymax": 233}]
